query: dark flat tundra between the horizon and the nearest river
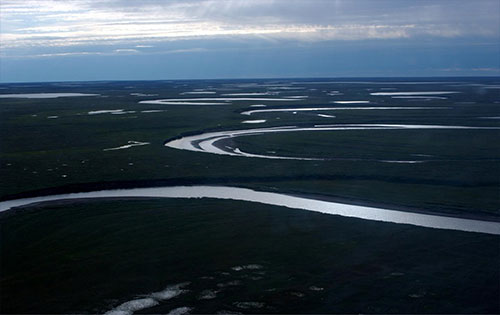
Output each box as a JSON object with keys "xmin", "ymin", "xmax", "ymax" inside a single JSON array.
[{"xmin": 0, "ymin": 78, "xmax": 500, "ymax": 215}]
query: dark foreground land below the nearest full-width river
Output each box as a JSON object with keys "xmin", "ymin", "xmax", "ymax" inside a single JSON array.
[{"xmin": 0, "ymin": 199, "xmax": 500, "ymax": 313}]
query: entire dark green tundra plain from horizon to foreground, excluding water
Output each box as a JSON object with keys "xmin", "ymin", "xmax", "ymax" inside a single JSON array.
[{"xmin": 0, "ymin": 78, "xmax": 500, "ymax": 313}]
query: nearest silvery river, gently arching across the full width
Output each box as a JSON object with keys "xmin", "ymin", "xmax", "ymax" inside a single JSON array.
[{"xmin": 0, "ymin": 186, "xmax": 500, "ymax": 235}]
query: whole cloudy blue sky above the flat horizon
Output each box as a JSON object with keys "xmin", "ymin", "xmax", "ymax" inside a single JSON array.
[{"xmin": 0, "ymin": 0, "xmax": 500, "ymax": 82}]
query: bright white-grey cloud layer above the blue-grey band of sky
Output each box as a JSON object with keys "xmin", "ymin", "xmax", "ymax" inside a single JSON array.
[{"xmin": 0, "ymin": 0, "xmax": 500, "ymax": 54}]
